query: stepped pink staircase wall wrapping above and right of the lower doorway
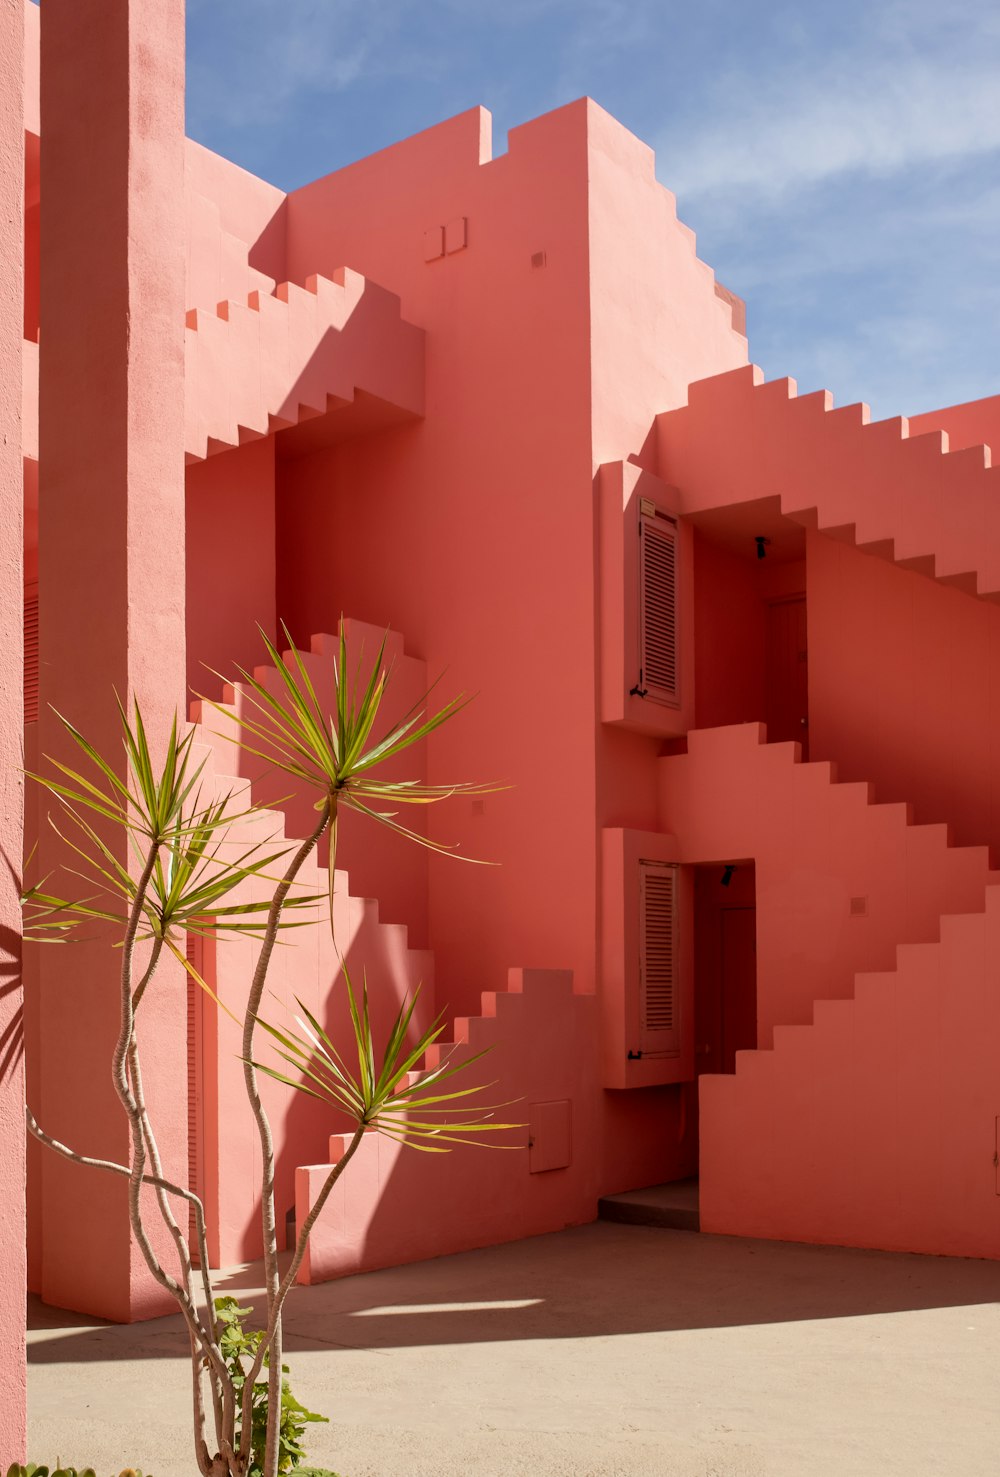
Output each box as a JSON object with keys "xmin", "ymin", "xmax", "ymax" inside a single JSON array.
[{"xmin": 660, "ymin": 724, "xmax": 1000, "ymax": 1046}]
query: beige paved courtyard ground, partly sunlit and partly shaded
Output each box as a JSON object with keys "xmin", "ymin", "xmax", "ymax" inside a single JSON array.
[{"xmin": 23, "ymin": 1223, "xmax": 1000, "ymax": 1477}]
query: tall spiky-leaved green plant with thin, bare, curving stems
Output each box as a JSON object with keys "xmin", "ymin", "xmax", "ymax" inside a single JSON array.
[{"xmin": 24, "ymin": 631, "xmax": 517, "ymax": 1477}]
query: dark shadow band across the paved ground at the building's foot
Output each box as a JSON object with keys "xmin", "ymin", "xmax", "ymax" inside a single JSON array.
[{"xmin": 28, "ymin": 1221, "xmax": 1000, "ymax": 1363}]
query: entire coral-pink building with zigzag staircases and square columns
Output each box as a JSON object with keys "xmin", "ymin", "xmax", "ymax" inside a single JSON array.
[{"xmin": 0, "ymin": 0, "xmax": 1000, "ymax": 1455}]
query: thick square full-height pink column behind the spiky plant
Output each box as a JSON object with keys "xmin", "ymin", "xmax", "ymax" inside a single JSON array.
[{"xmin": 35, "ymin": 0, "xmax": 186, "ymax": 1319}]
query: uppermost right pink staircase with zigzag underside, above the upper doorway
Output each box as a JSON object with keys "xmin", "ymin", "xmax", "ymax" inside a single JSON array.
[{"xmin": 657, "ymin": 365, "xmax": 1000, "ymax": 600}]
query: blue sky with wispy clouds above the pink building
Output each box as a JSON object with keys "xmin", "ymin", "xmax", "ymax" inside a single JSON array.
[{"xmin": 188, "ymin": 0, "xmax": 1000, "ymax": 417}]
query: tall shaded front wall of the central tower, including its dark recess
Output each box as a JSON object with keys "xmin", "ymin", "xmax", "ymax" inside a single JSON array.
[{"xmin": 278, "ymin": 103, "xmax": 595, "ymax": 1010}]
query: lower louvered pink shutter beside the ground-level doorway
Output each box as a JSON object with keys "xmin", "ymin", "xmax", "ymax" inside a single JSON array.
[{"xmin": 638, "ymin": 861, "xmax": 681, "ymax": 1056}]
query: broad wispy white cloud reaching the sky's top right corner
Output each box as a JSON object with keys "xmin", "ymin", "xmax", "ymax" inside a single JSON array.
[{"xmin": 660, "ymin": 0, "xmax": 1000, "ymax": 198}]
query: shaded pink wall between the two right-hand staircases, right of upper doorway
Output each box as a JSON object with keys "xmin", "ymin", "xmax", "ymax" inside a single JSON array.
[{"xmin": 808, "ymin": 535, "xmax": 1000, "ymax": 848}]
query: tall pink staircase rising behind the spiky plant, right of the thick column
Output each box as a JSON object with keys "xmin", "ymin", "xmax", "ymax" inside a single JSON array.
[{"xmin": 189, "ymin": 623, "xmax": 436, "ymax": 1266}]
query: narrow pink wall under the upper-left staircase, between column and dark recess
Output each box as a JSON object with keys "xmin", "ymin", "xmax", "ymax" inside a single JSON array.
[{"xmin": 185, "ymin": 437, "xmax": 276, "ymax": 696}]
